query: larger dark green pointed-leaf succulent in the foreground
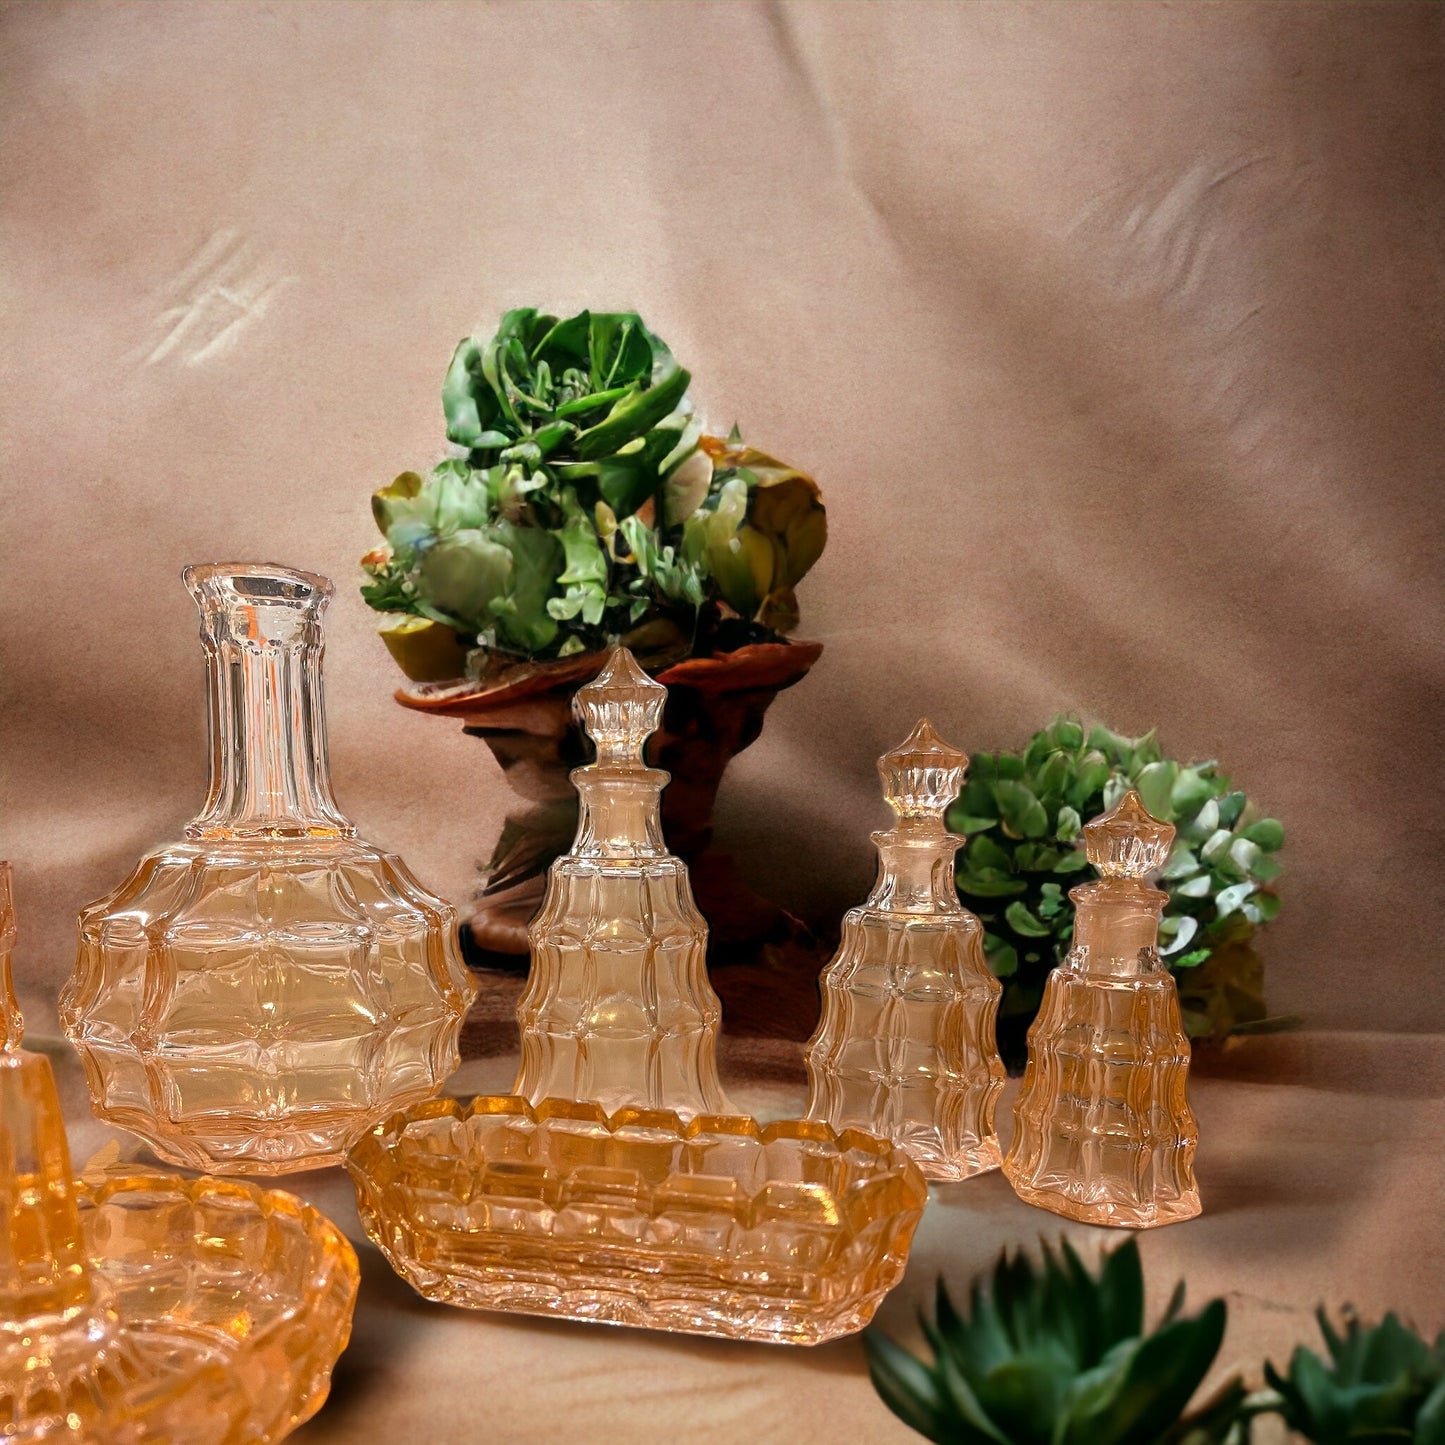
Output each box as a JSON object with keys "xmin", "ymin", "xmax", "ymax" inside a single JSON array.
[{"xmin": 864, "ymin": 1240, "xmax": 1246, "ymax": 1445}]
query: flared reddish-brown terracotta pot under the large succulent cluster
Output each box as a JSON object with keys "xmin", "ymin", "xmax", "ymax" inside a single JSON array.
[{"xmin": 396, "ymin": 642, "xmax": 822, "ymax": 994}]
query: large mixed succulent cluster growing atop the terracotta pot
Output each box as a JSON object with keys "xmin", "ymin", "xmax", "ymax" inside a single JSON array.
[{"xmin": 361, "ymin": 309, "xmax": 827, "ymax": 681}]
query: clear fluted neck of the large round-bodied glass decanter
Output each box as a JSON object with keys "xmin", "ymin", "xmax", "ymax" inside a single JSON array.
[{"xmin": 185, "ymin": 564, "xmax": 355, "ymax": 838}]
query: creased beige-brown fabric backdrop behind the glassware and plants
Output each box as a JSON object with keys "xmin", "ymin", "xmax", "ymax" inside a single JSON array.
[{"xmin": 0, "ymin": 0, "xmax": 1445, "ymax": 1032}]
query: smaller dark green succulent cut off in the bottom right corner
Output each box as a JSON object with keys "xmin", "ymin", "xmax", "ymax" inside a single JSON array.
[{"xmin": 1256, "ymin": 1309, "xmax": 1445, "ymax": 1445}]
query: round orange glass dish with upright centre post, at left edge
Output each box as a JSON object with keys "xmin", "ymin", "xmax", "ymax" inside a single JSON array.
[{"xmin": 0, "ymin": 866, "xmax": 358, "ymax": 1445}]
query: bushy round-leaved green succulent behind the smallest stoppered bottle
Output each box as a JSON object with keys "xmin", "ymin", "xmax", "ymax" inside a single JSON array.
[{"xmin": 948, "ymin": 717, "xmax": 1286, "ymax": 1066}]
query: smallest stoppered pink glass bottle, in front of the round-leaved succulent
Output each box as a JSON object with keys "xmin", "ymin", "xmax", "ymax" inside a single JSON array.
[{"xmin": 1003, "ymin": 792, "xmax": 1199, "ymax": 1228}]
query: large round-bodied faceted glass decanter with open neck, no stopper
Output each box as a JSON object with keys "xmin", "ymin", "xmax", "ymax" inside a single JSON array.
[{"xmin": 61, "ymin": 564, "xmax": 475, "ymax": 1173}]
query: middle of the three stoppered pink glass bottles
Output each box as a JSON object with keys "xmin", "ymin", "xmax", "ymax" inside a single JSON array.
[{"xmin": 808, "ymin": 718, "xmax": 1004, "ymax": 1179}]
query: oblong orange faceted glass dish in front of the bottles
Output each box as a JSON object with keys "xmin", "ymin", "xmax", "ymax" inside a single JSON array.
[{"xmin": 350, "ymin": 1095, "xmax": 928, "ymax": 1344}]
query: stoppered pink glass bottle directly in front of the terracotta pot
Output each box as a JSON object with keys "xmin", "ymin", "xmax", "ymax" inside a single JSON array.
[{"xmin": 514, "ymin": 647, "xmax": 728, "ymax": 1118}]
